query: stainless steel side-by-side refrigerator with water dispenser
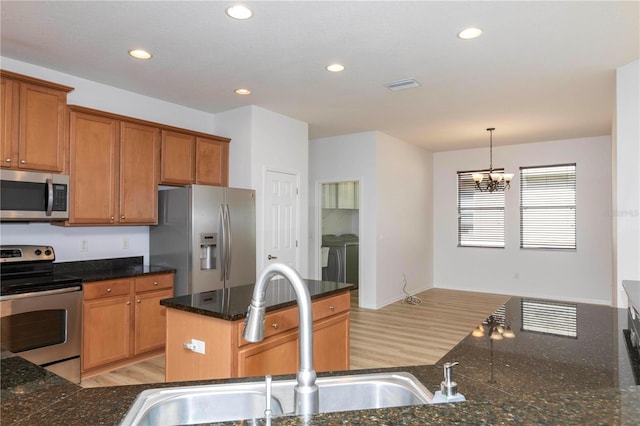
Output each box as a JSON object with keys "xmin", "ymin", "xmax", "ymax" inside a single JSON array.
[{"xmin": 149, "ymin": 185, "xmax": 256, "ymax": 296}]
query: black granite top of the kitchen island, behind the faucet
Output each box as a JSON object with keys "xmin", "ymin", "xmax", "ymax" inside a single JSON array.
[{"xmin": 160, "ymin": 278, "xmax": 354, "ymax": 321}]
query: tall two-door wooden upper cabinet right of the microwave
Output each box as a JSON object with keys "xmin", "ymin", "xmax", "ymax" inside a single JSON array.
[{"xmin": 68, "ymin": 107, "xmax": 159, "ymax": 225}]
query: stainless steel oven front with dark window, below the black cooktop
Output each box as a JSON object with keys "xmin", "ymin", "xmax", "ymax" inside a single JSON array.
[{"xmin": 0, "ymin": 287, "xmax": 82, "ymax": 383}]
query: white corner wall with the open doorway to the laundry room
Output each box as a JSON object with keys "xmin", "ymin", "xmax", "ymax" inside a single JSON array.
[{"xmin": 309, "ymin": 132, "xmax": 432, "ymax": 309}]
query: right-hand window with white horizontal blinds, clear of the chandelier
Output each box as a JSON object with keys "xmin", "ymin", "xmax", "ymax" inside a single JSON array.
[{"xmin": 520, "ymin": 164, "xmax": 576, "ymax": 249}]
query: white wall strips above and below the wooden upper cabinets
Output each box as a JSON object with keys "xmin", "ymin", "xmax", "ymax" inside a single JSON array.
[{"xmin": 0, "ymin": 57, "xmax": 214, "ymax": 262}]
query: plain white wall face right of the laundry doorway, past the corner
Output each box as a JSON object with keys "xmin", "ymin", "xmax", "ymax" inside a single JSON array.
[{"xmin": 376, "ymin": 133, "xmax": 433, "ymax": 307}]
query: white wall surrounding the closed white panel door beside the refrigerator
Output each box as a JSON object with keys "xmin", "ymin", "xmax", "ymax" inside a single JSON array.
[{"xmin": 215, "ymin": 105, "xmax": 309, "ymax": 277}]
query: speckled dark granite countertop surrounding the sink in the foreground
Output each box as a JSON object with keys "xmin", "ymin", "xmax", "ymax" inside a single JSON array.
[{"xmin": 1, "ymin": 297, "xmax": 640, "ymax": 426}]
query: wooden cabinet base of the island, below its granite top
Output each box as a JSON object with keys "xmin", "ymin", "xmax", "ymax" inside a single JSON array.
[{"xmin": 165, "ymin": 291, "xmax": 350, "ymax": 381}]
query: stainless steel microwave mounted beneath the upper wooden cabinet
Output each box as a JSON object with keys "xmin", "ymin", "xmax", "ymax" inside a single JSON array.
[{"xmin": 0, "ymin": 170, "xmax": 69, "ymax": 222}]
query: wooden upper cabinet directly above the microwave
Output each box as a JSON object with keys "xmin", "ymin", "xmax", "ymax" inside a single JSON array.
[{"xmin": 0, "ymin": 70, "xmax": 73, "ymax": 173}]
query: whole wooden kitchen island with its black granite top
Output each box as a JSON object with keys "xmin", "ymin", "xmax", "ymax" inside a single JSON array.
[{"xmin": 160, "ymin": 278, "xmax": 353, "ymax": 382}]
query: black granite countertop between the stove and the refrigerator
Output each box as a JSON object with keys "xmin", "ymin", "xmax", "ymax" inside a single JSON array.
[{"xmin": 53, "ymin": 256, "xmax": 175, "ymax": 282}]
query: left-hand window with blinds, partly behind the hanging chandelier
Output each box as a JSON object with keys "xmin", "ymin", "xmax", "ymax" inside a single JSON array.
[{"xmin": 458, "ymin": 169, "xmax": 504, "ymax": 247}]
